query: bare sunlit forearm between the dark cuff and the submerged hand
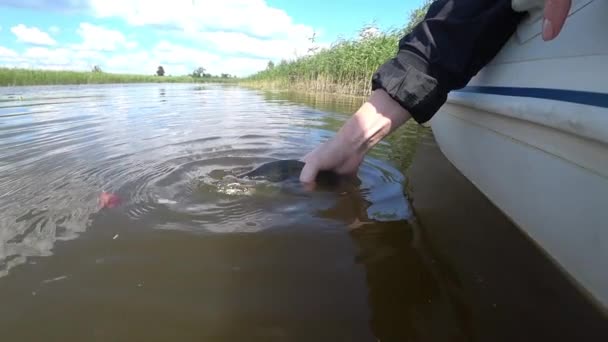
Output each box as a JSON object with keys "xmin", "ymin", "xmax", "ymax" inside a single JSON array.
[{"xmin": 336, "ymin": 90, "xmax": 411, "ymax": 155}]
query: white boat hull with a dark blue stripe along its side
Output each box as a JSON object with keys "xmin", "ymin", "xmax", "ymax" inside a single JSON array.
[{"xmin": 430, "ymin": 0, "xmax": 608, "ymax": 312}]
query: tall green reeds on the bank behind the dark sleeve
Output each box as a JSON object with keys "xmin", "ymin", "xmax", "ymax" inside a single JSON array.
[{"xmin": 241, "ymin": 0, "xmax": 432, "ymax": 95}]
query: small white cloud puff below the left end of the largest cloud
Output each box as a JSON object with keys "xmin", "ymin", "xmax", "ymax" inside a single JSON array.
[{"xmin": 76, "ymin": 23, "xmax": 137, "ymax": 51}]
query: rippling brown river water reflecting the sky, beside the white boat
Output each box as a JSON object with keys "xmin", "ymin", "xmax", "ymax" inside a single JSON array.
[{"xmin": 0, "ymin": 85, "xmax": 606, "ymax": 341}]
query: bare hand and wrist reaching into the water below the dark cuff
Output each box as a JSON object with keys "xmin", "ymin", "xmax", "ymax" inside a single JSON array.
[{"xmin": 300, "ymin": 90, "xmax": 411, "ymax": 187}]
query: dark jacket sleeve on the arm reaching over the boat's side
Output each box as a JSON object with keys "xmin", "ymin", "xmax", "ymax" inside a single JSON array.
[{"xmin": 372, "ymin": 0, "xmax": 523, "ymax": 123}]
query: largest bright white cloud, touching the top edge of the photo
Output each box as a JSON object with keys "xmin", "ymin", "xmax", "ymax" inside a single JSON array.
[{"xmin": 91, "ymin": 0, "xmax": 324, "ymax": 64}]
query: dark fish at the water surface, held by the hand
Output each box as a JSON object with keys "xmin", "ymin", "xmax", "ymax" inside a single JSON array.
[{"xmin": 239, "ymin": 159, "xmax": 347, "ymax": 186}]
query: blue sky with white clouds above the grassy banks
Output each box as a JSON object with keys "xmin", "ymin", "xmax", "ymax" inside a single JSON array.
[{"xmin": 0, "ymin": 0, "xmax": 423, "ymax": 76}]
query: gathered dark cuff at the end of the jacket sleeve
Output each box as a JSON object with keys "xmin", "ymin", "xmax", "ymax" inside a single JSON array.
[{"xmin": 372, "ymin": 50, "xmax": 447, "ymax": 124}]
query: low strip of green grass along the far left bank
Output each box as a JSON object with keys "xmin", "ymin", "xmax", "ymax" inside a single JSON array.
[{"xmin": 0, "ymin": 68, "xmax": 236, "ymax": 86}]
